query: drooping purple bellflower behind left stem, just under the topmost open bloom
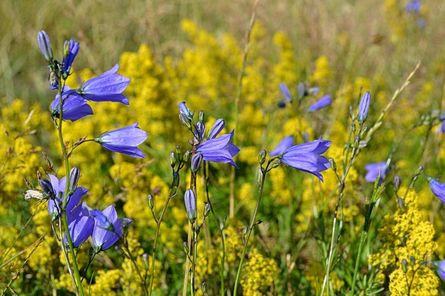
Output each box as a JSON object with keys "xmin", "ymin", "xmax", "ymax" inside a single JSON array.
[{"xmin": 51, "ymin": 86, "xmax": 93, "ymax": 121}]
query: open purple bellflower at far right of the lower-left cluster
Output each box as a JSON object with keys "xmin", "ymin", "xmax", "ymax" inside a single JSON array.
[{"xmin": 91, "ymin": 205, "xmax": 132, "ymax": 252}]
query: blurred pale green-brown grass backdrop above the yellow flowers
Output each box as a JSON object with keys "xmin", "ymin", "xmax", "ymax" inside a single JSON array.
[{"xmin": 0, "ymin": 0, "xmax": 445, "ymax": 100}]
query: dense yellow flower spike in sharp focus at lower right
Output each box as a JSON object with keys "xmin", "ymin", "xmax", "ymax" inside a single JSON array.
[{"xmin": 369, "ymin": 188, "xmax": 439, "ymax": 295}]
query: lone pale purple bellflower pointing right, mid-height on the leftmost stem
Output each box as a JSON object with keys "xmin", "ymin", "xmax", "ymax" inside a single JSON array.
[{"xmin": 96, "ymin": 123, "xmax": 147, "ymax": 158}]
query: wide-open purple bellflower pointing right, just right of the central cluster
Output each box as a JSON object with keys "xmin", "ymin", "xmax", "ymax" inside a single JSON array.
[{"xmin": 270, "ymin": 137, "xmax": 331, "ymax": 181}]
